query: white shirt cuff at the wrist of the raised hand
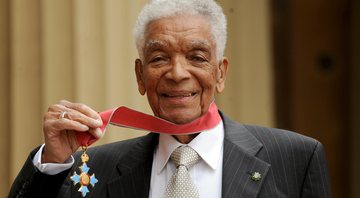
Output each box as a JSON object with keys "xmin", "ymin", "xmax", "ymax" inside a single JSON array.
[{"xmin": 33, "ymin": 144, "xmax": 74, "ymax": 175}]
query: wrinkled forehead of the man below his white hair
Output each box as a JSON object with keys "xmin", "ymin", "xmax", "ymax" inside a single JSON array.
[{"xmin": 144, "ymin": 15, "xmax": 214, "ymax": 48}]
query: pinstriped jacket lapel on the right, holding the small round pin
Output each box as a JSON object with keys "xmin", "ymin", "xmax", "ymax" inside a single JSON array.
[{"xmin": 221, "ymin": 113, "xmax": 270, "ymax": 198}]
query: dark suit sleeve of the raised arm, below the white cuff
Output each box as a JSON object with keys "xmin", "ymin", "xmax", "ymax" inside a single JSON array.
[{"xmin": 8, "ymin": 148, "xmax": 69, "ymax": 198}]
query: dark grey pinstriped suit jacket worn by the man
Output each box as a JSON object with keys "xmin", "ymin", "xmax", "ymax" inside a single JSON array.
[{"xmin": 9, "ymin": 114, "xmax": 331, "ymax": 198}]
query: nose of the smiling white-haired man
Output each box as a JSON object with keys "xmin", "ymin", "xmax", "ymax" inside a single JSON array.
[{"xmin": 166, "ymin": 58, "xmax": 191, "ymax": 82}]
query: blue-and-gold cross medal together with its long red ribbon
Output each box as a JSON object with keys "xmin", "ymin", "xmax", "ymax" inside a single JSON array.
[{"xmin": 67, "ymin": 102, "xmax": 221, "ymax": 197}]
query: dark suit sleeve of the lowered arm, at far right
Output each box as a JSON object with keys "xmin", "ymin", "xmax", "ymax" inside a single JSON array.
[{"xmin": 301, "ymin": 142, "xmax": 332, "ymax": 198}]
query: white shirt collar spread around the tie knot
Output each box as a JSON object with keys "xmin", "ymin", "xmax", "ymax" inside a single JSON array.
[{"xmin": 155, "ymin": 121, "xmax": 224, "ymax": 174}]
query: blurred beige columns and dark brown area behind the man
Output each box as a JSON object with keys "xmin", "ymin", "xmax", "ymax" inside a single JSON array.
[{"xmin": 0, "ymin": 0, "xmax": 360, "ymax": 198}]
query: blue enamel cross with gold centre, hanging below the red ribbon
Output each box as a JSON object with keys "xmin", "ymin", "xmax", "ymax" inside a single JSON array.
[{"xmin": 70, "ymin": 146, "xmax": 98, "ymax": 197}]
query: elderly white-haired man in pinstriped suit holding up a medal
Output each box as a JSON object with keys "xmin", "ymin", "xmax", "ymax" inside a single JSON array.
[{"xmin": 9, "ymin": 0, "xmax": 331, "ymax": 198}]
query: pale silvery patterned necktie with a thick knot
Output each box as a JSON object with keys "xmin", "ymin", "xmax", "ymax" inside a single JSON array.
[{"xmin": 165, "ymin": 146, "xmax": 200, "ymax": 198}]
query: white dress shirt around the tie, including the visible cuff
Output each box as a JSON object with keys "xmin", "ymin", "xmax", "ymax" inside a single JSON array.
[{"xmin": 33, "ymin": 121, "xmax": 224, "ymax": 198}]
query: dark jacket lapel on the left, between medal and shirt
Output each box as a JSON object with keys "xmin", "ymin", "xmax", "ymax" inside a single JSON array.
[{"xmin": 107, "ymin": 134, "xmax": 158, "ymax": 198}]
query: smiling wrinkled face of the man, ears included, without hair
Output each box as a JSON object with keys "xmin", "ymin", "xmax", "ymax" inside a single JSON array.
[{"xmin": 135, "ymin": 15, "xmax": 227, "ymax": 124}]
